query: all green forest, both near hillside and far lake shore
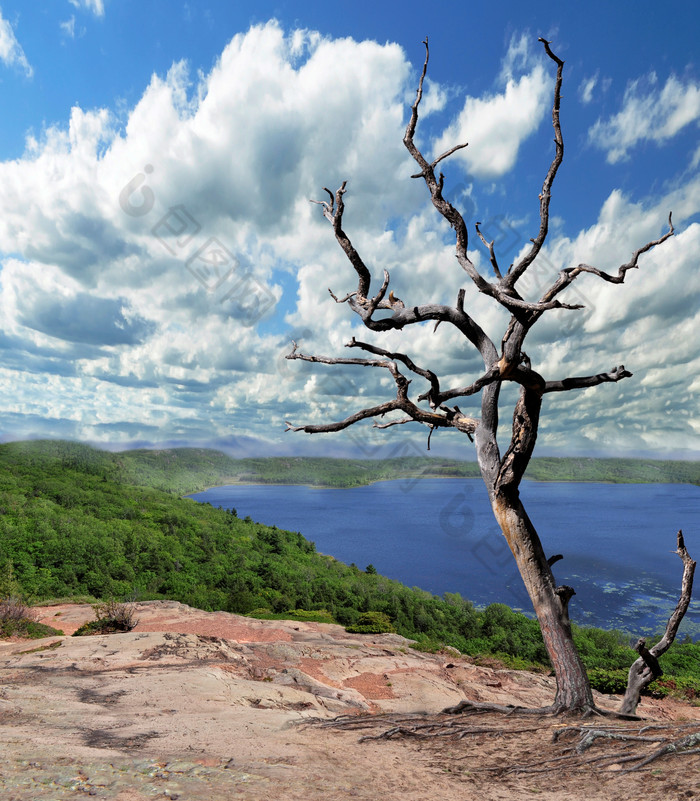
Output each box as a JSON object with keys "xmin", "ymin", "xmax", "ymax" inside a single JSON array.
[{"xmin": 0, "ymin": 441, "xmax": 700, "ymax": 696}]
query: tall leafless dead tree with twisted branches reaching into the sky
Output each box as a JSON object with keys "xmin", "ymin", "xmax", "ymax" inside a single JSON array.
[{"xmin": 287, "ymin": 39, "xmax": 673, "ymax": 712}]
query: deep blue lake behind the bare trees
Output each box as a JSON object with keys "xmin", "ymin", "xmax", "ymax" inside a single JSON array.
[{"xmin": 191, "ymin": 479, "xmax": 700, "ymax": 637}]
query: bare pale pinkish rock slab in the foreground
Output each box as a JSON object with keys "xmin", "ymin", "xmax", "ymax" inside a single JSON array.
[{"xmin": 0, "ymin": 601, "xmax": 690, "ymax": 801}]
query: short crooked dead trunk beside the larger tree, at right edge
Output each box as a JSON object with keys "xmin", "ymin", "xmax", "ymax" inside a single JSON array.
[{"xmin": 620, "ymin": 531, "xmax": 695, "ymax": 715}]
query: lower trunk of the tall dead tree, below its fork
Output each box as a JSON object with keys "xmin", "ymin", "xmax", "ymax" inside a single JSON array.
[{"xmin": 491, "ymin": 493, "xmax": 595, "ymax": 713}]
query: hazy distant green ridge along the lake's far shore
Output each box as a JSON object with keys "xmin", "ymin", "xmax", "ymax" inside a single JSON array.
[{"xmin": 0, "ymin": 440, "xmax": 700, "ymax": 495}]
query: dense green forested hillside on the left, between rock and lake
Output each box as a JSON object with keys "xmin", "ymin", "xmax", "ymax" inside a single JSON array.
[{"xmin": 0, "ymin": 443, "xmax": 506, "ymax": 657}]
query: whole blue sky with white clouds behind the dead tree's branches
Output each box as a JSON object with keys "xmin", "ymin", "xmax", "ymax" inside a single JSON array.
[{"xmin": 0, "ymin": 0, "xmax": 700, "ymax": 458}]
